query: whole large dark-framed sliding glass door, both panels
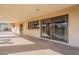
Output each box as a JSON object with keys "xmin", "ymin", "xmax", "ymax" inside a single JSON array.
[{"xmin": 41, "ymin": 15, "xmax": 68, "ymax": 42}]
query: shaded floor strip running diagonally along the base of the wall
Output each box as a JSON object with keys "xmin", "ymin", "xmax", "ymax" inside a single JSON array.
[{"xmin": 20, "ymin": 34, "xmax": 79, "ymax": 55}]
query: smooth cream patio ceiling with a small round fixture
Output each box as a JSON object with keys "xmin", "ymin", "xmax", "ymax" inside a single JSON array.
[{"xmin": 0, "ymin": 4, "xmax": 73, "ymax": 22}]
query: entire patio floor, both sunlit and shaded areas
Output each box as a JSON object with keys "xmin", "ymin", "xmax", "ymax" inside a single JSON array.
[{"xmin": 0, "ymin": 32, "xmax": 79, "ymax": 55}]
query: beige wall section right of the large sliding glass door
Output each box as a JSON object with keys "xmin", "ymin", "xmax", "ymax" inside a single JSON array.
[{"xmin": 69, "ymin": 6, "xmax": 79, "ymax": 47}]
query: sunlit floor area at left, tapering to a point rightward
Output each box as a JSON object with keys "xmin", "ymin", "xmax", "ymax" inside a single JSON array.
[{"xmin": 0, "ymin": 33, "xmax": 35, "ymax": 46}]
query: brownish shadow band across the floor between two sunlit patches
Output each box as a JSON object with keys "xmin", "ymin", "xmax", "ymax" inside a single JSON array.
[{"xmin": 0, "ymin": 44, "xmax": 46, "ymax": 54}]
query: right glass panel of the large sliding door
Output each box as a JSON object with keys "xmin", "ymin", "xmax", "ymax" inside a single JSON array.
[{"xmin": 52, "ymin": 16, "xmax": 68, "ymax": 42}]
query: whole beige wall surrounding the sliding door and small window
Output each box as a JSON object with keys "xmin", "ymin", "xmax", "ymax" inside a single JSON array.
[{"xmin": 14, "ymin": 5, "xmax": 79, "ymax": 47}]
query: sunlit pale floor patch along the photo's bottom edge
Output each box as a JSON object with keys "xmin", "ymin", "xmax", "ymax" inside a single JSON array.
[{"xmin": 9, "ymin": 49, "xmax": 62, "ymax": 55}]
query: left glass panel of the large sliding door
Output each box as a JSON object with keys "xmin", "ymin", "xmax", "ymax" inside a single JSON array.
[{"xmin": 41, "ymin": 20, "xmax": 51, "ymax": 39}]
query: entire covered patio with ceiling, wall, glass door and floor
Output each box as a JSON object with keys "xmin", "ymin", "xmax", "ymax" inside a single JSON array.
[{"xmin": 0, "ymin": 4, "xmax": 79, "ymax": 55}]
